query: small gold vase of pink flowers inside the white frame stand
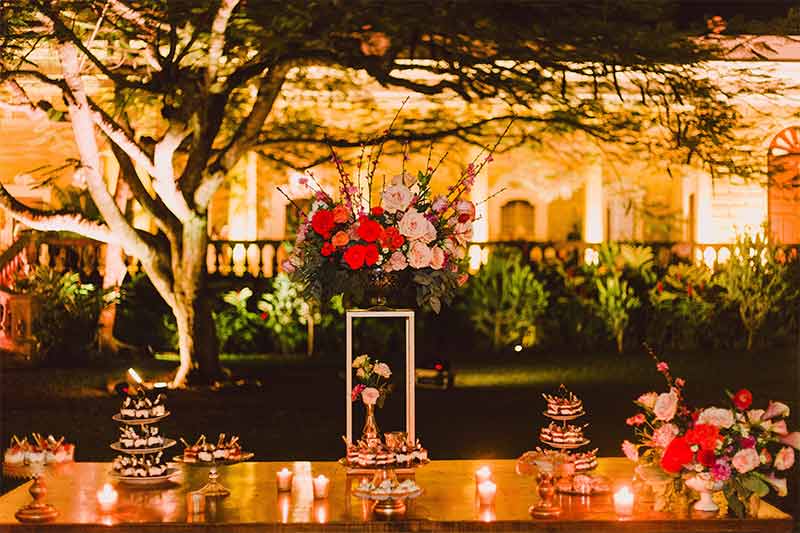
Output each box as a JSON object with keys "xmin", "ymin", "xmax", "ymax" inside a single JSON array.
[{"xmin": 351, "ymin": 354, "xmax": 393, "ymax": 444}]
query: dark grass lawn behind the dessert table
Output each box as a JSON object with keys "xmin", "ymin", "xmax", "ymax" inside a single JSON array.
[{"xmin": 0, "ymin": 347, "xmax": 800, "ymax": 512}]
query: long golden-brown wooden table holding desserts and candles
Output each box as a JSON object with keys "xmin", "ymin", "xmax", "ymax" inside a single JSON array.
[{"xmin": 0, "ymin": 458, "xmax": 793, "ymax": 533}]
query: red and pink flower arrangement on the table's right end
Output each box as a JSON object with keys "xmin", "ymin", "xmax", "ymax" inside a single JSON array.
[{"xmin": 622, "ymin": 354, "xmax": 800, "ymax": 517}]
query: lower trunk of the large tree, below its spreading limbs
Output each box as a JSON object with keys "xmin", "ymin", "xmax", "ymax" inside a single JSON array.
[{"xmin": 173, "ymin": 215, "xmax": 223, "ymax": 387}]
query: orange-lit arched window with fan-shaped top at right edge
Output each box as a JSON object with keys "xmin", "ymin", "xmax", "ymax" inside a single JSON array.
[{"xmin": 767, "ymin": 126, "xmax": 800, "ymax": 244}]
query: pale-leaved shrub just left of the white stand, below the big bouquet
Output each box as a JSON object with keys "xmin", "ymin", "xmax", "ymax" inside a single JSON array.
[{"xmin": 258, "ymin": 273, "xmax": 321, "ymax": 353}]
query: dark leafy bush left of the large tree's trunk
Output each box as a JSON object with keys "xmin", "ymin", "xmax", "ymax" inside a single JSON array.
[{"xmin": 17, "ymin": 266, "xmax": 105, "ymax": 366}]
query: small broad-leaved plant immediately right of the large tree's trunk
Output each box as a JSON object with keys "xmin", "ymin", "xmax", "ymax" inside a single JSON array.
[{"xmin": 214, "ymin": 287, "xmax": 264, "ymax": 351}]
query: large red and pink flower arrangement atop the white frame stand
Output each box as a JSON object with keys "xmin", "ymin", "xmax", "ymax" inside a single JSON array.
[{"xmin": 283, "ymin": 108, "xmax": 510, "ymax": 313}]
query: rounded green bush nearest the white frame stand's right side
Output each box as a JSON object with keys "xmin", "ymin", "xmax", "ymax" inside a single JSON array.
[{"xmin": 465, "ymin": 252, "xmax": 548, "ymax": 351}]
